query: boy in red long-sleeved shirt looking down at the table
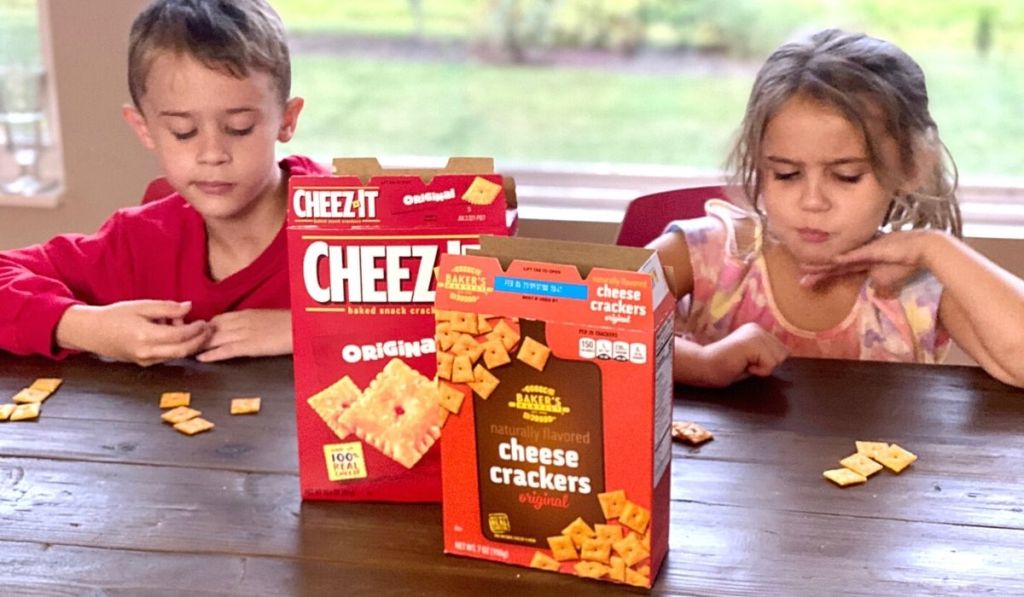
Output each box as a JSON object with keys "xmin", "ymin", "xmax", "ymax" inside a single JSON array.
[{"xmin": 0, "ymin": 0, "xmax": 326, "ymax": 366}]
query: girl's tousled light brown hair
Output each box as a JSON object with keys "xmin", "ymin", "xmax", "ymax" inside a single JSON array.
[{"xmin": 728, "ymin": 29, "xmax": 962, "ymax": 237}]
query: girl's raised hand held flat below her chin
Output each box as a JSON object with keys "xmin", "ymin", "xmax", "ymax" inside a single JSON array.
[{"xmin": 800, "ymin": 230, "xmax": 940, "ymax": 297}]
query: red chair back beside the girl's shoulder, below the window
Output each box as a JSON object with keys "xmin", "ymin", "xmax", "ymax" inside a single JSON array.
[{"xmin": 615, "ymin": 186, "xmax": 727, "ymax": 247}]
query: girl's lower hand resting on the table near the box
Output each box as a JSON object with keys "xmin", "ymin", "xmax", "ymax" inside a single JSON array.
[{"xmin": 688, "ymin": 324, "xmax": 790, "ymax": 387}]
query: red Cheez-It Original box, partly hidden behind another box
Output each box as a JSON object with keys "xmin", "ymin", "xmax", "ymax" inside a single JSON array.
[{"xmin": 288, "ymin": 158, "xmax": 516, "ymax": 502}]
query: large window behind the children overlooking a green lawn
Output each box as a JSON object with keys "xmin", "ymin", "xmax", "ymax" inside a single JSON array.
[{"xmin": 272, "ymin": 0, "xmax": 1024, "ymax": 234}]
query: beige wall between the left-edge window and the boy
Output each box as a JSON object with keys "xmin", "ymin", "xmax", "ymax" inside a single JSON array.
[{"xmin": 0, "ymin": 0, "xmax": 159, "ymax": 249}]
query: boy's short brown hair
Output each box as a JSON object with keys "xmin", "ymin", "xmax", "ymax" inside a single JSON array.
[{"xmin": 128, "ymin": 0, "xmax": 292, "ymax": 109}]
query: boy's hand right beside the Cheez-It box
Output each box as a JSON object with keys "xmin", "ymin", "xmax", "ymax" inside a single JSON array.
[{"xmin": 196, "ymin": 309, "xmax": 292, "ymax": 363}]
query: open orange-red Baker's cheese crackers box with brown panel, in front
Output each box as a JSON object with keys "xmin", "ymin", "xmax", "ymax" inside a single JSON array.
[{"xmin": 436, "ymin": 237, "xmax": 675, "ymax": 588}]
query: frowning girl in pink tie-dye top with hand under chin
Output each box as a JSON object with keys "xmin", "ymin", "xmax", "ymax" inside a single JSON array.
[{"xmin": 650, "ymin": 30, "xmax": 1024, "ymax": 387}]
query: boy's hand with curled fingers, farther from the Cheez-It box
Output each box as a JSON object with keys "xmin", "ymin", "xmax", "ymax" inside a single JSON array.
[{"xmin": 54, "ymin": 300, "xmax": 210, "ymax": 367}]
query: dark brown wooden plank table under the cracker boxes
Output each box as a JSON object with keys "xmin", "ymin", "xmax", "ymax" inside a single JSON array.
[{"xmin": 0, "ymin": 355, "xmax": 1024, "ymax": 597}]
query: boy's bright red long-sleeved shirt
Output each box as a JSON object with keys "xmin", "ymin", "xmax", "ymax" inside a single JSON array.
[{"xmin": 0, "ymin": 156, "xmax": 330, "ymax": 358}]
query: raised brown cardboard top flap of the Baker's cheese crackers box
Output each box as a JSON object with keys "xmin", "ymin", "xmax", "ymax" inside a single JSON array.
[{"xmin": 469, "ymin": 236, "xmax": 654, "ymax": 279}]
